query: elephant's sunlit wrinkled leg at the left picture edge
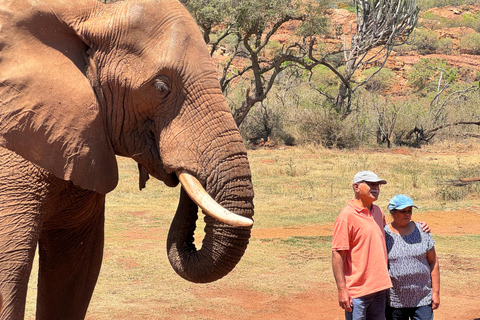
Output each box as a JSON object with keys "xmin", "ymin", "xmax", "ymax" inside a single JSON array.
[{"xmin": 0, "ymin": 148, "xmax": 46, "ymax": 320}]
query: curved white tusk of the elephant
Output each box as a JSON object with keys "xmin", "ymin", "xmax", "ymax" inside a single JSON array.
[{"xmin": 176, "ymin": 171, "xmax": 253, "ymax": 227}]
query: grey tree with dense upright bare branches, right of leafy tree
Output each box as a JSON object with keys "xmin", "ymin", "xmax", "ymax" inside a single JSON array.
[{"xmin": 314, "ymin": 0, "xmax": 420, "ymax": 117}]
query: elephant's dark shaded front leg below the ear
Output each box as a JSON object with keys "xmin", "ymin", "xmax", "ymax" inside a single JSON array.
[{"xmin": 36, "ymin": 190, "xmax": 105, "ymax": 320}]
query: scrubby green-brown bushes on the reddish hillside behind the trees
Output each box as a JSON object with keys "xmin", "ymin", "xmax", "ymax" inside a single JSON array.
[{"xmin": 216, "ymin": 1, "xmax": 480, "ymax": 148}]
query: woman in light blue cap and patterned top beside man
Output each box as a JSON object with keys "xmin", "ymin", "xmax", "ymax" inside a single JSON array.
[{"xmin": 385, "ymin": 194, "xmax": 440, "ymax": 320}]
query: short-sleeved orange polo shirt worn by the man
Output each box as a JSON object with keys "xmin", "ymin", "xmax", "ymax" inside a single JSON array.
[{"xmin": 332, "ymin": 200, "xmax": 392, "ymax": 298}]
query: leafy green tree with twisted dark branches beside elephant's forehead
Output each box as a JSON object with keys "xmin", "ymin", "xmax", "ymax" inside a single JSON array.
[{"xmin": 182, "ymin": 0, "xmax": 327, "ymax": 125}]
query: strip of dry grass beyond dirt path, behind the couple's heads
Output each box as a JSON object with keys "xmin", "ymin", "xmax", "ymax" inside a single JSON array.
[{"xmin": 250, "ymin": 148, "xmax": 480, "ymax": 228}]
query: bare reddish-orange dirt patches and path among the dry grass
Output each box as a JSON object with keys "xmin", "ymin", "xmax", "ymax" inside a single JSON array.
[{"xmin": 163, "ymin": 206, "xmax": 480, "ymax": 320}]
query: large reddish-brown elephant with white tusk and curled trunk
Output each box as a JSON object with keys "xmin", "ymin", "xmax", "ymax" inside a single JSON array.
[{"xmin": 0, "ymin": 0, "xmax": 254, "ymax": 320}]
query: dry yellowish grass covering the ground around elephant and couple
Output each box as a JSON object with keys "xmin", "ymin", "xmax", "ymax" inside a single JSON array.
[{"xmin": 26, "ymin": 145, "xmax": 480, "ymax": 320}]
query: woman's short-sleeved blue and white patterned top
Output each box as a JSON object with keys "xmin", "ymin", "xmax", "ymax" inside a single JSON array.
[{"xmin": 384, "ymin": 223, "xmax": 435, "ymax": 308}]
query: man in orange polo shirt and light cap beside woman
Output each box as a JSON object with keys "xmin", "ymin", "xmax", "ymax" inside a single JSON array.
[{"xmin": 332, "ymin": 171, "xmax": 392, "ymax": 320}]
